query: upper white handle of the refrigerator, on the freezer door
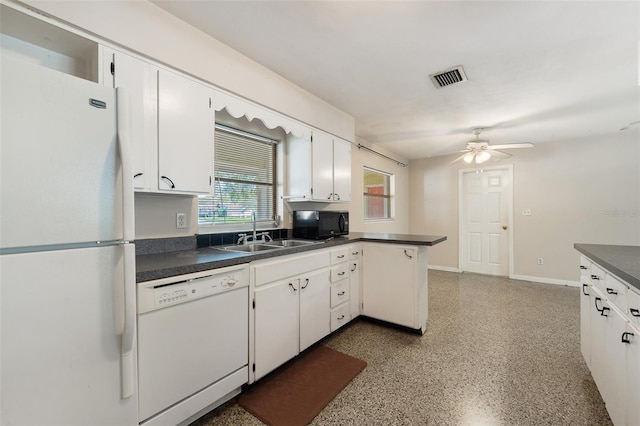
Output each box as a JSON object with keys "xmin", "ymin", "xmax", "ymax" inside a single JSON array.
[{"xmin": 116, "ymin": 87, "xmax": 135, "ymax": 241}]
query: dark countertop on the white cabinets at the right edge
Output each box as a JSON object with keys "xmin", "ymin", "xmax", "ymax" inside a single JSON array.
[{"xmin": 573, "ymin": 244, "xmax": 640, "ymax": 290}]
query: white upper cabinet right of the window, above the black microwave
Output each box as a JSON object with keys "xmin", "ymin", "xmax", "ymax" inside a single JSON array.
[{"xmin": 286, "ymin": 129, "xmax": 351, "ymax": 203}]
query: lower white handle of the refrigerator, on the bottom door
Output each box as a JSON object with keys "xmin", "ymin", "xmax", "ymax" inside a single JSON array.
[{"xmin": 116, "ymin": 244, "xmax": 136, "ymax": 399}]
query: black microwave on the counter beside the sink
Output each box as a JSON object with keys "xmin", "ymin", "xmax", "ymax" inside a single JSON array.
[{"xmin": 293, "ymin": 210, "xmax": 349, "ymax": 240}]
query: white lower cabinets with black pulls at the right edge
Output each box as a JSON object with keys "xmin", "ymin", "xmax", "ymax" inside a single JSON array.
[{"xmin": 580, "ymin": 256, "xmax": 640, "ymax": 426}]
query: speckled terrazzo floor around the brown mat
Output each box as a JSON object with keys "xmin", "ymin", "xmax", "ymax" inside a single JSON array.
[{"xmin": 193, "ymin": 271, "xmax": 611, "ymax": 426}]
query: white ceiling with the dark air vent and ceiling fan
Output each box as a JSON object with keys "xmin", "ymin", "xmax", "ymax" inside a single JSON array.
[{"xmin": 151, "ymin": 0, "xmax": 640, "ymax": 159}]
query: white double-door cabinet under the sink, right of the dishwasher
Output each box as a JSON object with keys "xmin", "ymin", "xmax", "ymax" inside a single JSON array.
[{"xmin": 249, "ymin": 250, "xmax": 331, "ymax": 382}]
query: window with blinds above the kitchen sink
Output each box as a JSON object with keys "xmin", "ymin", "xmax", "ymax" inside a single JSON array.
[{"xmin": 198, "ymin": 124, "xmax": 277, "ymax": 225}]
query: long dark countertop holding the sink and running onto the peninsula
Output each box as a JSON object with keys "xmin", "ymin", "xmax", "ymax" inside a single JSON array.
[{"xmin": 136, "ymin": 232, "xmax": 447, "ymax": 282}]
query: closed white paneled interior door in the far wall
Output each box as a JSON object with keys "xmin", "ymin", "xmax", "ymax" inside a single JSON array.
[{"xmin": 460, "ymin": 168, "xmax": 512, "ymax": 276}]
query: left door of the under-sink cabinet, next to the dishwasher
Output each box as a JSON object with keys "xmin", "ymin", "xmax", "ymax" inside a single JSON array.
[{"xmin": 254, "ymin": 279, "xmax": 298, "ymax": 380}]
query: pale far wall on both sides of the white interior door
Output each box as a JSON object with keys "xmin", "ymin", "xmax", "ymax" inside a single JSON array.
[{"xmin": 410, "ymin": 129, "xmax": 640, "ymax": 282}]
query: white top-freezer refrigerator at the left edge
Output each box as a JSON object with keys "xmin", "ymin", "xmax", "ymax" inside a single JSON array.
[{"xmin": 0, "ymin": 55, "xmax": 138, "ymax": 426}]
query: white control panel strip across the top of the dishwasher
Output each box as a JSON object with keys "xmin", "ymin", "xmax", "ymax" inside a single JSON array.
[{"xmin": 138, "ymin": 265, "xmax": 249, "ymax": 314}]
